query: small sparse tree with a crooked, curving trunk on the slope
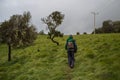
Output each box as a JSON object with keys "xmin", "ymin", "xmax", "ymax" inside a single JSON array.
[{"xmin": 41, "ymin": 11, "xmax": 64, "ymax": 45}]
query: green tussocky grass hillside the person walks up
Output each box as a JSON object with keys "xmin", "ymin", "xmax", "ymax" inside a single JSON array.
[{"xmin": 0, "ymin": 34, "xmax": 120, "ymax": 80}]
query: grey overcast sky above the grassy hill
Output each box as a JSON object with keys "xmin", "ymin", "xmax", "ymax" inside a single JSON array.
[{"xmin": 0, "ymin": 0, "xmax": 120, "ymax": 34}]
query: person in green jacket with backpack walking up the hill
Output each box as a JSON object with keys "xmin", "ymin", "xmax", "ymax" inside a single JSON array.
[{"xmin": 65, "ymin": 35, "xmax": 77, "ymax": 68}]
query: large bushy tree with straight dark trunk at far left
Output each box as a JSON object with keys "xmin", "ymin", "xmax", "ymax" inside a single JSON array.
[{"xmin": 0, "ymin": 12, "xmax": 36, "ymax": 61}]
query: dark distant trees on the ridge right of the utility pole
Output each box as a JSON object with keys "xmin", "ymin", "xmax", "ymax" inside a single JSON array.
[{"xmin": 92, "ymin": 20, "xmax": 120, "ymax": 34}]
